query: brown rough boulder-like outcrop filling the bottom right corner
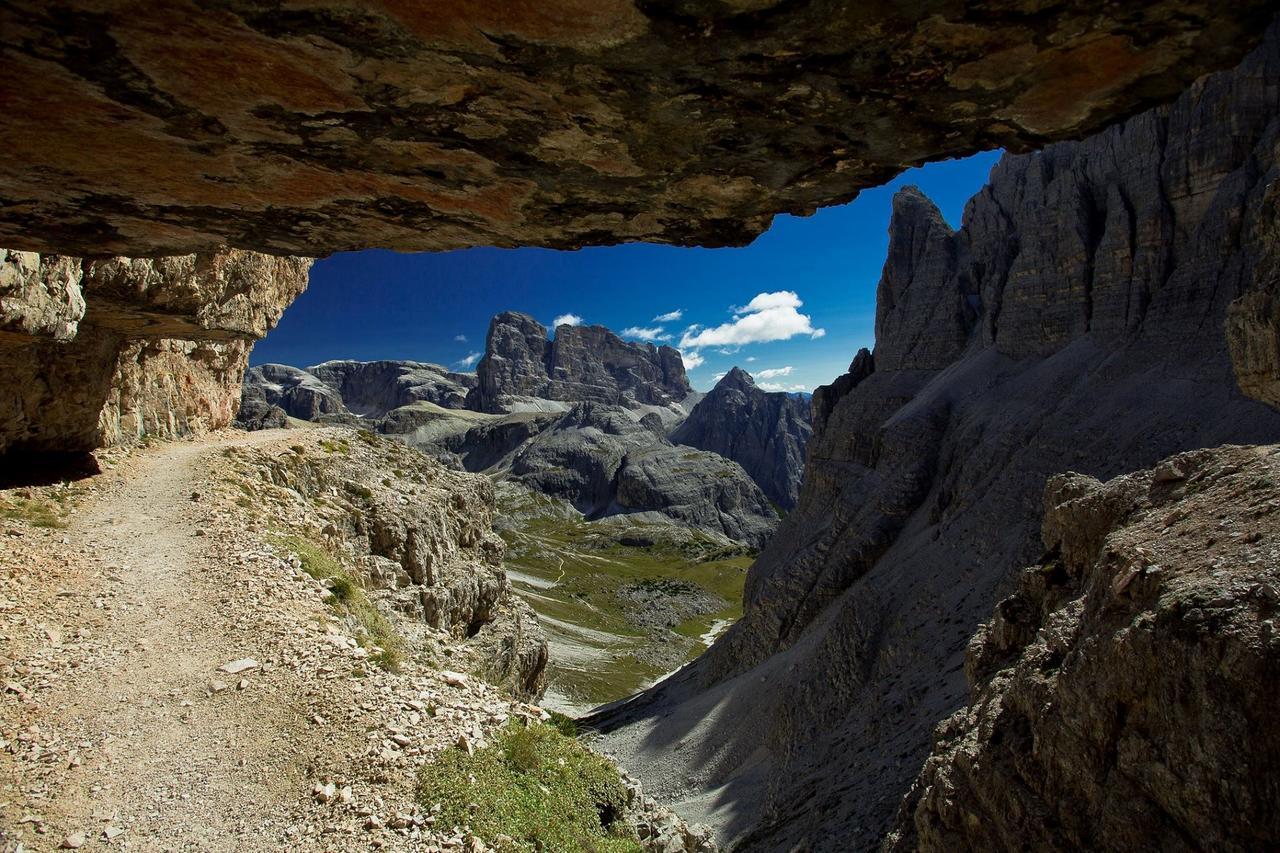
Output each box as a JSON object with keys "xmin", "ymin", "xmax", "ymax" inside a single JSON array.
[{"xmin": 887, "ymin": 447, "xmax": 1280, "ymax": 852}]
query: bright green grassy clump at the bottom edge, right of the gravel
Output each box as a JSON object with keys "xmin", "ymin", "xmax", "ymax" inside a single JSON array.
[{"xmin": 417, "ymin": 722, "xmax": 643, "ymax": 853}]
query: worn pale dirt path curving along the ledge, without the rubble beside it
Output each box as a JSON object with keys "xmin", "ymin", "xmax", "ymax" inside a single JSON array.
[{"xmin": 5, "ymin": 433, "xmax": 355, "ymax": 849}]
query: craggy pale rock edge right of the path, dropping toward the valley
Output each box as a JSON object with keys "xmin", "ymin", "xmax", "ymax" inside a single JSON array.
[{"xmin": 241, "ymin": 429, "xmax": 547, "ymax": 698}]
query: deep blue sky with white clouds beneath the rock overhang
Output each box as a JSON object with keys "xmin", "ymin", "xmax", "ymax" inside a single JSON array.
[{"xmin": 252, "ymin": 152, "xmax": 998, "ymax": 391}]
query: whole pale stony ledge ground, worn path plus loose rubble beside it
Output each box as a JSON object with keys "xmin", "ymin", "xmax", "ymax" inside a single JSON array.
[{"xmin": 0, "ymin": 430, "xmax": 560, "ymax": 850}]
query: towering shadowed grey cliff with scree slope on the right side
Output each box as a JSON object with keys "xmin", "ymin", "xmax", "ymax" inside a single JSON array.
[{"xmin": 593, "ymin": 24, "xmax": 1280, "ymax": 850}]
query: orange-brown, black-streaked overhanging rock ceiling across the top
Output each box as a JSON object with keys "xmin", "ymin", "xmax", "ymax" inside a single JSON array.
[{"xmin": 0, "ymin": 0, "xmax": 1274, "ymax": 256}]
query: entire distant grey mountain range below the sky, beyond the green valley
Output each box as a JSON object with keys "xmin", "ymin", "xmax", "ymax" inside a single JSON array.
[{"xmin": 241, "ymin": 311, "xmax": 812, "ymax": 540}]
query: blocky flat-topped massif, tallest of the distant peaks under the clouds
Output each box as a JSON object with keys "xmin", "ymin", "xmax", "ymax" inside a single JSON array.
[{"xmin": 467, "ymin": 311, "xmax": 691, "ymax": 412}]
